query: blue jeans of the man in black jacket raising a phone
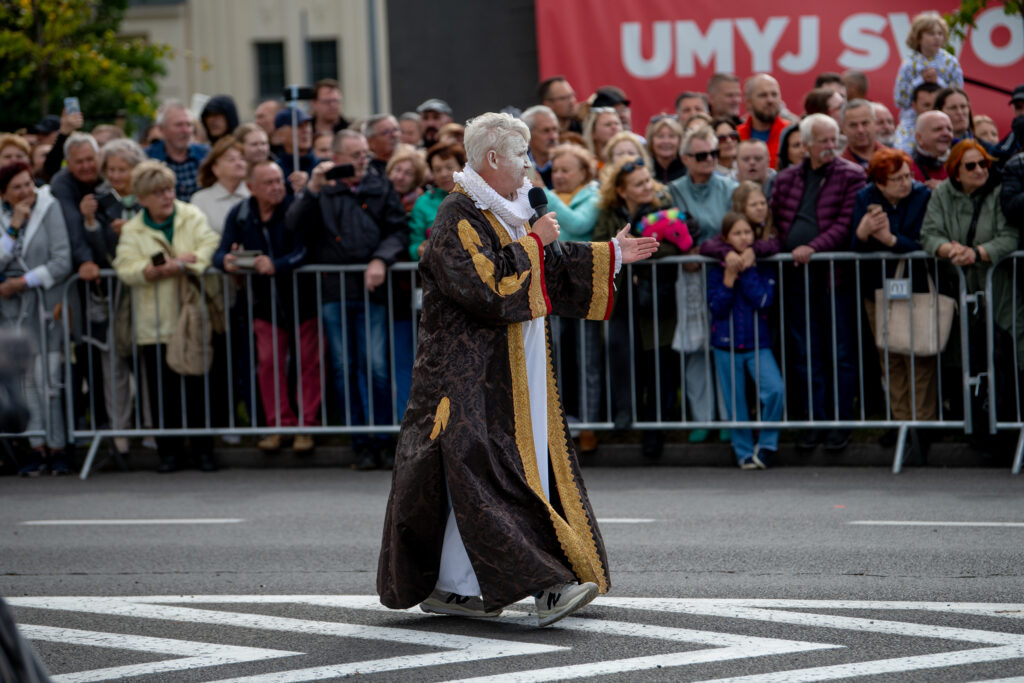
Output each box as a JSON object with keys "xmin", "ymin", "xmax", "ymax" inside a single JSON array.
[{"xmin": 324, "ymin": 299, "xmax": 392, "ymax": 446}]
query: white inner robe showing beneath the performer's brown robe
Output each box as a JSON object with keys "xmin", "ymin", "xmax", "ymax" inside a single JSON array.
[{"xmin": 437, "ymin": 214, "xmax": 551, "ymax": 595}]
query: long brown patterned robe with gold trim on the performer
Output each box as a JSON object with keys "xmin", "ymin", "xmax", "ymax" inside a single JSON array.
[{"xmin": 377, "ymin": 186, "xmax": 615, "ymax": 609}]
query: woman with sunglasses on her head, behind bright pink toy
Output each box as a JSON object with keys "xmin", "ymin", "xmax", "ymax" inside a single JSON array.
[{"xmin": 594, "ymin": 160, "xmax": 683, "ymax": 459}]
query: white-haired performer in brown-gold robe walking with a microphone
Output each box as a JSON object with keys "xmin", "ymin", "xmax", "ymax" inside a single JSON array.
[{"xmin": 377, "ymin": 109, "xmax": 656, "ymax": 627}]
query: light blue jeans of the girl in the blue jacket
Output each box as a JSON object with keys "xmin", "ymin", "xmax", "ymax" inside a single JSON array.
[{"xmin": 712, "ymin": 348, "xmax": 785, "ymax": 461}]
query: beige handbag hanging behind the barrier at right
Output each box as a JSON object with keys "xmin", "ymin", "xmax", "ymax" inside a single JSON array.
[{"xmin": 874, "ymin": 259, "xmax": 956, "ymax": 356}]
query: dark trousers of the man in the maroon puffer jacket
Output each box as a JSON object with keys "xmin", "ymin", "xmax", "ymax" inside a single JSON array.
[{"xmin": 784, "ymin": 263, "xmax": 857, "ymax": 420}]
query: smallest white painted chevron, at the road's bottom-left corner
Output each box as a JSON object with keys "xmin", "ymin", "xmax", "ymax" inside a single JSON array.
[{"xmin": 18, "ymin": 624, "xmax": 296, "ymax": 683}]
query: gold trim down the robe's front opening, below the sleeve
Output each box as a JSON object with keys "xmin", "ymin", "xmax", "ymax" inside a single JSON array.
[{"xmin": 508, "ymin": 323, "xmax": 608, "ymax": 593}]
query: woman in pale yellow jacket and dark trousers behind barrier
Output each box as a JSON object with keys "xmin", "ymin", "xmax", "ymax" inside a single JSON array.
[{"xmin": 114, "ymin": 161, "xmax": 223, "ymax": 472}]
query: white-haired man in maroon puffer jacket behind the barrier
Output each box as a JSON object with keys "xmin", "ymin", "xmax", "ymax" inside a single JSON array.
[{"xmin": 771, "ymin": 114, "xmax": 867, "ymax": 452}]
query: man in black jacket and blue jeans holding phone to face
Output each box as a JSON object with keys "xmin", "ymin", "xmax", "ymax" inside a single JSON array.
[{"xmin": 288, "ymin": 130, "xmax": 409, "ymax": 469}]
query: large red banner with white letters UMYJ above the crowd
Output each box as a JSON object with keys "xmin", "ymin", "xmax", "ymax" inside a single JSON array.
[{"xmin": 536, "ymin": 0, "xmax": 1024, "ymax": 137}]
